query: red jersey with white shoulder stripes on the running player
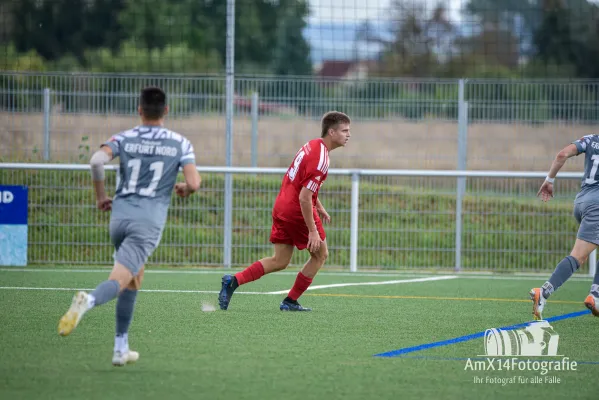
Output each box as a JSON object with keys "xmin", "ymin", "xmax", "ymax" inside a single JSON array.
[{"xmin": 273, "ymin": 139, "xmax": 329, "ymax": 224}]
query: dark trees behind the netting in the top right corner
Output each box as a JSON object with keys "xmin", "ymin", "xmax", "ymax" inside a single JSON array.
[{"xmin": 465, "ymin": 0, "xmax": 599, "ymax": 78}]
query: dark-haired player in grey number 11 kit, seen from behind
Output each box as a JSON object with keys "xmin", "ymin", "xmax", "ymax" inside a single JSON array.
[{"xmin": 58, "ymin": 87, "xmax": 201, "ymax": 366}]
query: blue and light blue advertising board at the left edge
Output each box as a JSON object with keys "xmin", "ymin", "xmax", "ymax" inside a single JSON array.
[{"xmin": 0, "ymin": 185, "xmax": 28, "ymax": 266}]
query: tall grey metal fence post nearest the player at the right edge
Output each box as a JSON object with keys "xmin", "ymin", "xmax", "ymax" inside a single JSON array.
[{"xmin": 455, "ymin": 79, "xmax": 468, "ymax": 271}]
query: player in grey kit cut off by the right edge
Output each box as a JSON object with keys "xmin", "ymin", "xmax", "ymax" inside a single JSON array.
[{"xmin": 530, "ymin": 135, "xmax": 599, "ymax": 320}]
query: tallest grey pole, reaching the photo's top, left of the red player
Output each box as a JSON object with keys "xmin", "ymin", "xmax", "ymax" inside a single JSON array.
[{"xmin": 223, "ymin": 0, "xmax": 235, "ymax": 268}]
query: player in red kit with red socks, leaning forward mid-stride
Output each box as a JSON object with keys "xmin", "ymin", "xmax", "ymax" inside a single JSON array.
[{"xmin": 218, "ymin": 111, "xmax": 351, "ymax": 311}]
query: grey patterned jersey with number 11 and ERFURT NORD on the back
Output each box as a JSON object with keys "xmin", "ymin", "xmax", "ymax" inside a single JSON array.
[{"xmin": 104, "ymin": 126, "xmax": 195, "ymax": 227}]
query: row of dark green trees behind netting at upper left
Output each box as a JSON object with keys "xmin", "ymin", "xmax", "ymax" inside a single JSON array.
[{"xmin": 7, "ymin": 0, "xmax": 311, "ymax": 74}]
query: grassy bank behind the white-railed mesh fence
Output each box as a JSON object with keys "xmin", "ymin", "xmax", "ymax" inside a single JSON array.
[{"xmin": 0, "ymin": 170, "xmax": 584, "ymax": 271}]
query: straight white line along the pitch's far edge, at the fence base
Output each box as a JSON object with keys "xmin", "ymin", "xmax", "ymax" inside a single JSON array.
[{"xmin": 0, "ymin": 267, "xmax": 592, "ymax": 281}]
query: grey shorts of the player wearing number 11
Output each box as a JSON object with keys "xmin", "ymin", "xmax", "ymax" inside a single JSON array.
[{"xmin": 110, "ymin": 219, "xmax": 162, "ymax": 276}]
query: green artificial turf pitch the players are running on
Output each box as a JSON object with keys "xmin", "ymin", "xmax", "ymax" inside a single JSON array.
[{"xmin": 0, "ymin": 269, "xmax": 599, "ymax": 400}]
